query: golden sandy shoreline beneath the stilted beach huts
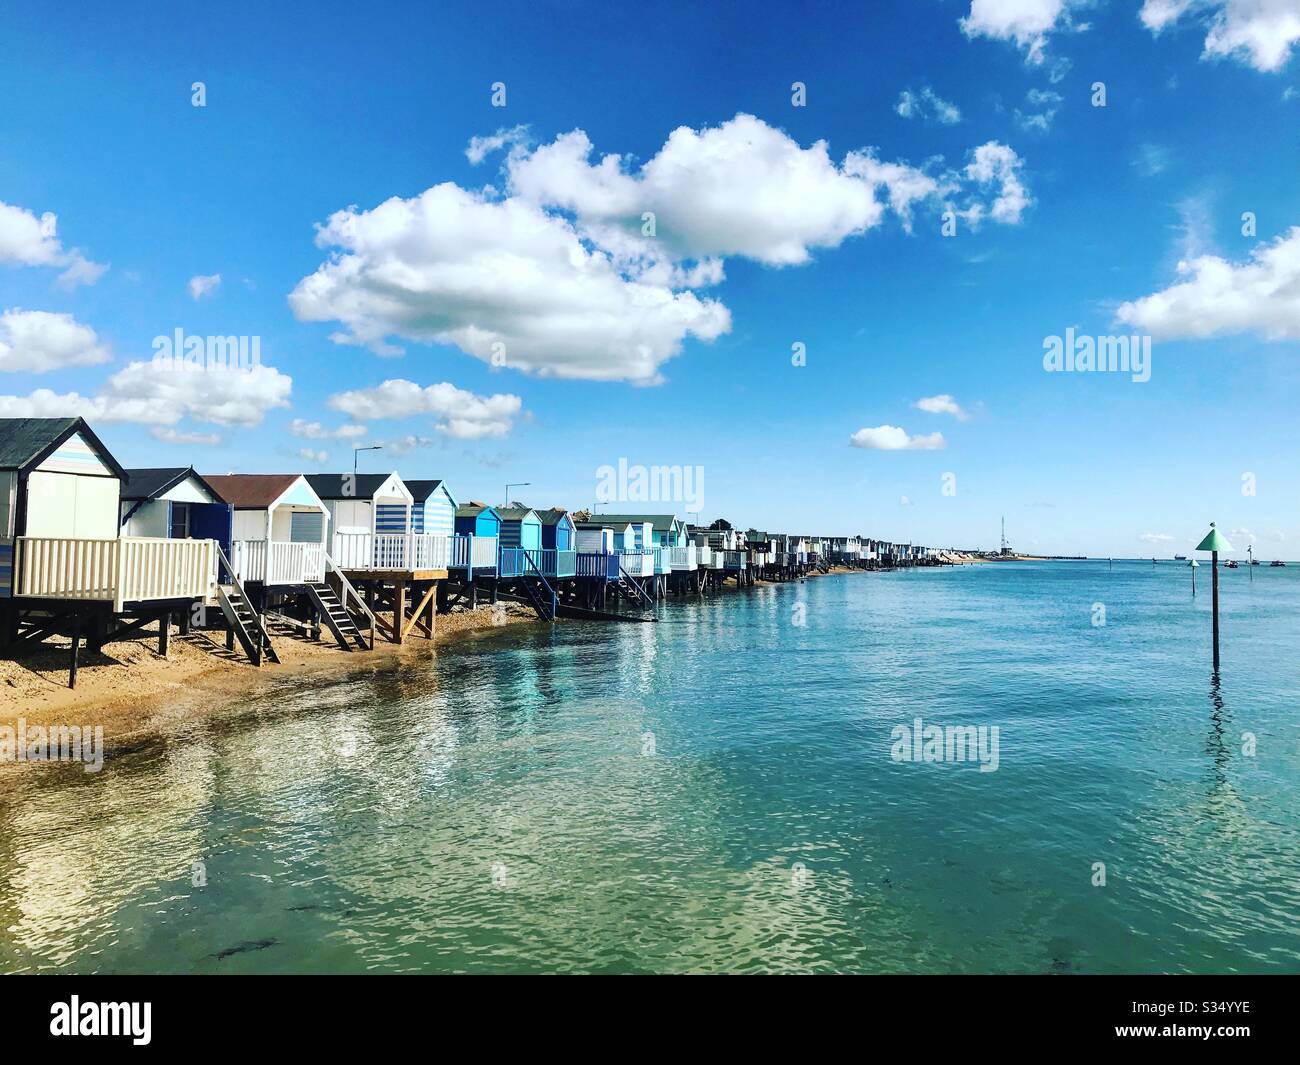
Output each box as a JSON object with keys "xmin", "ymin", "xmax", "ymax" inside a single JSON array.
[{"xmin": 0, "ymin": 559, "xmax": 956, "ymax": 788}]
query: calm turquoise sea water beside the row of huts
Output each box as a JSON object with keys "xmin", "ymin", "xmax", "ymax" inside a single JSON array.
[{"xmin": 0, "ymin": 562, "xmax": 1300, "ymax": 973}]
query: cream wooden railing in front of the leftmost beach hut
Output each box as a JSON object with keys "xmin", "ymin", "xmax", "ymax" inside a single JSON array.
[{"xmin": 13, "ymin": 536, "xmax": 217, "ymax": 610}]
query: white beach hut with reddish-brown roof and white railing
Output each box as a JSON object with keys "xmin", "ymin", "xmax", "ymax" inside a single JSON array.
[{"xmin": 204, "ymin": 473, "xmax": 330, "ymax": 586}]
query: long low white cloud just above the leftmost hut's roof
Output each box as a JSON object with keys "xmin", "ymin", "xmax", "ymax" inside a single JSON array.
[{"xmin": 0, "ymin": 362, "xmax": 293, "ymax": 427}]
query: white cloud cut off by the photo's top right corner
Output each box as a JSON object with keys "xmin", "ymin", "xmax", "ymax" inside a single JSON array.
[{"xmin": 1139, "ymin": 0, "xmax": 1300, "ymax": 72}]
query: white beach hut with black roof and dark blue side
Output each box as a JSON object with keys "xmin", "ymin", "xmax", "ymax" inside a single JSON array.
[{"xmin": 121, "ymin": 466, "xmax": 233, "ymax": 554}]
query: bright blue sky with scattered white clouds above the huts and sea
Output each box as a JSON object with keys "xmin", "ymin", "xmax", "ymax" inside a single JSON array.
[{"xmin": 0, "ymin": 0, "xmax": 1300, "ymax": 558}]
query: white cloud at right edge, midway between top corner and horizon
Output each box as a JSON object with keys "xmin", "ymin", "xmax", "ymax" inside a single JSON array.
[{"xmin": 1115, "ymin": 226, "xmax": 1300, "ymax": 341}]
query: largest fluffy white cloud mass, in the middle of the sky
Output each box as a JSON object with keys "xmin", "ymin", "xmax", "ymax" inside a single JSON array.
[{"xmin": 290, "ymin": 114, "xmax": 1028, "ymax": 384}]
